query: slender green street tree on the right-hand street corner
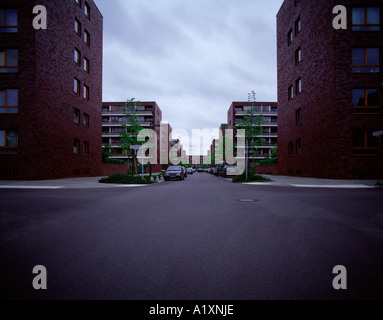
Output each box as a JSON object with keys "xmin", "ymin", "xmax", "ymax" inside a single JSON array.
[{"xmin": 235, "ymin": 90, "xmax": 265, "ymax": 178}]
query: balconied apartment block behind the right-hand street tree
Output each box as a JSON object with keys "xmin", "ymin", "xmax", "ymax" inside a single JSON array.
[{"xmin": 227, "ymin": 102, "xmax": 278, "ymax": 160}]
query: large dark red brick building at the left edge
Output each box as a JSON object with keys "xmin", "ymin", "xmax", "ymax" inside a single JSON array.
[{"xmin": 0, "ymin": 0, "xmax": 103, "ymax": 180}]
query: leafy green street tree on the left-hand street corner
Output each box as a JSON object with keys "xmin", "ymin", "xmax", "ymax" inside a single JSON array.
[{"xmin": 119, "ymin": 98, "xmax": 144, "ymax": 175}]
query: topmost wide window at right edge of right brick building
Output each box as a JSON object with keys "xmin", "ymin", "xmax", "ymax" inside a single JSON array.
[{"xmin": 352, "ymin": 7, "xmax": 380, "ymax": 31}]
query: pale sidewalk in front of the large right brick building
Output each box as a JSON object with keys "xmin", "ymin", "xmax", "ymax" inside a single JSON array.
[{"xmin": 246, "ymin": 175, "xmax": 377, "ymax": 189}]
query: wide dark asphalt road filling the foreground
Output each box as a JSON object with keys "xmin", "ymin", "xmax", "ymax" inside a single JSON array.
[{"xmin": 0, "ymin": 173, "xmax": 383, "ymax": 300}]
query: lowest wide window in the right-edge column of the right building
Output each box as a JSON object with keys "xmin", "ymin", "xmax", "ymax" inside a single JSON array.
[{"xmin": 352, "ymin": 129, "xmax": 380, "ymax": 155}]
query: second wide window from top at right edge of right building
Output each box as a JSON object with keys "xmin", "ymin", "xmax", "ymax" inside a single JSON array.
[{"xmin": 352, "ymin": 48, "xmax": 380, "ymax": 72}]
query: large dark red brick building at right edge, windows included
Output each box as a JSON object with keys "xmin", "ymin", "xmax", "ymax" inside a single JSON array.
[{"xmin": 277, "ymin": 0, "xmax": 383, "ymax": 179}]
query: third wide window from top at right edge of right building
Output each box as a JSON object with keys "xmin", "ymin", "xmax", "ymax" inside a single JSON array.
[{"xmin": 352, "ymin": 89, "xmax": 382, "ymax": 113}]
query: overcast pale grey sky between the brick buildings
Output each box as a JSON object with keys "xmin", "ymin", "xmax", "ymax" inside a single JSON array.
[{"xmin": 95, "ymin": 0, "xmax": 283, "ymax": 154}]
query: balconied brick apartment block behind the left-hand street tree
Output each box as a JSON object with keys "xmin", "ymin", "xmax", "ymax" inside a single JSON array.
[{"xmin": 102, "ymin": 102, "xmax": 163, "ymax": 172}]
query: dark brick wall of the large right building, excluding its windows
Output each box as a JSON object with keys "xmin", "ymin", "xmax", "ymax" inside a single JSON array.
[{"xmin": 277, "ymin": 0, "xmax": 383, "ymax": 178}]
